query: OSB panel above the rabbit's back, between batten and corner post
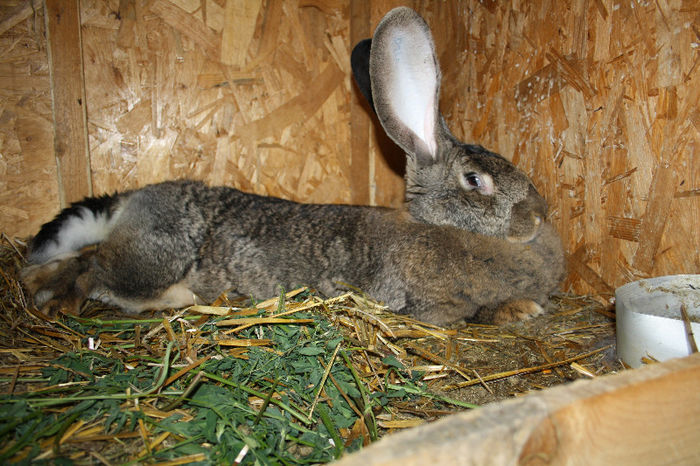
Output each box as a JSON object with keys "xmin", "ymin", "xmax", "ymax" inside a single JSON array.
[{"xmin": 81, "ymin": 0, "xmax": 372, "ymax": 202}]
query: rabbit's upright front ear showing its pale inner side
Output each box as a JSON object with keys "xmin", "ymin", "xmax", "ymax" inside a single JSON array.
[{"xmin": 370, "ymin": 7, "xmax": 443, "ymax": 164}]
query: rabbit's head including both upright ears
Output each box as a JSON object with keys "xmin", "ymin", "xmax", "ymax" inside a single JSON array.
[{"xmin": 352, "ymin": 7, "xmax": 546, "ymax": 242}]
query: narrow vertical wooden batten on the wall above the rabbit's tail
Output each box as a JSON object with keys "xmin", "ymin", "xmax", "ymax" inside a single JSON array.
[{"xmin": 46, "ymin": 0, "xmax": 92, "ymax": 206}]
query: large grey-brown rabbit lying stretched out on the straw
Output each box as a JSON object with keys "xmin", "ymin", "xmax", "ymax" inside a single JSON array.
[{"xmin": 22, "ymin": 7, "xmax": 564, "ymax": 325}]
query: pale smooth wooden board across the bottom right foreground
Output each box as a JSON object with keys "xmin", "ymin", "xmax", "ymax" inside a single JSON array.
[{"xmin": 337, "ymin": 354, "xmax": 700, "ymax": 466}]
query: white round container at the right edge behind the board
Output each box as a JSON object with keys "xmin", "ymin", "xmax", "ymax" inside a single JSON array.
[{"xmin": 615, "ymin": 275, "xmax": 700, "ymax": 367}]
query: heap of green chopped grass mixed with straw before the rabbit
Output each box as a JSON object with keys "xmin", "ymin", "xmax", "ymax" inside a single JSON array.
[{"xmin": 0, "ymin": 294, "xmax": 464, "ymax": 464}]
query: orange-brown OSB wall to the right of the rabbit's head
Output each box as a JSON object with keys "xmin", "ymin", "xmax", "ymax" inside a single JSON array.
[{"xmin": 408, "ymin": 0, "xmax": 700, "ymax": 294}]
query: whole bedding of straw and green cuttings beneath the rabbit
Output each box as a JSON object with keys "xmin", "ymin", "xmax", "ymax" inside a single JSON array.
[{"xmin": 0, "ymin": 237, "xmax": 622, "ymax": 464}]
